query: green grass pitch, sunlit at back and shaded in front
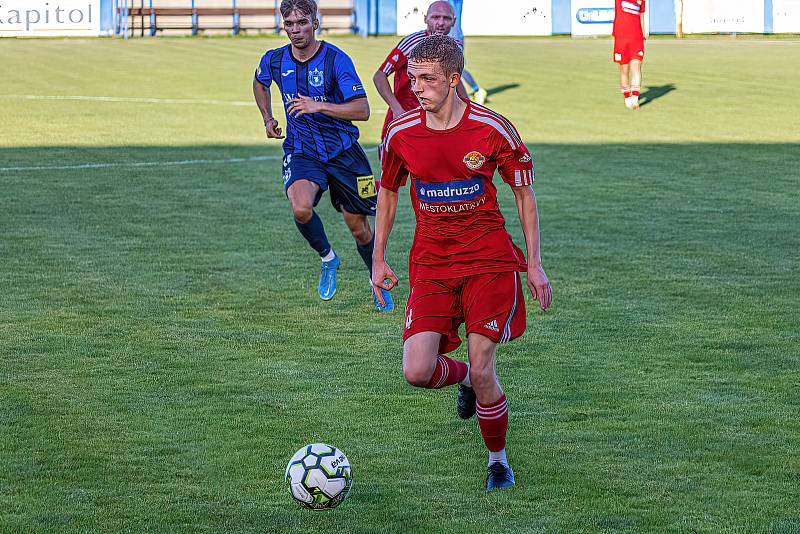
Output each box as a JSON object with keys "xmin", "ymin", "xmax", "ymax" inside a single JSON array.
[{"xmin": 0, "ymin": 37, "xmax": 800, "ymax": 532}]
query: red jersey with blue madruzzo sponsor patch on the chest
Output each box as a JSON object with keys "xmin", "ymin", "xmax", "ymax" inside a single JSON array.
[{"xmin": 380, "ymin": 102, "xmax": 533, "ymax": 283}]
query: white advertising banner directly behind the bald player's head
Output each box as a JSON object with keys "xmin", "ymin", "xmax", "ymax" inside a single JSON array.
[{"xmin": 397, "ymin": 0, "xmax": 552, "ymax": 35}]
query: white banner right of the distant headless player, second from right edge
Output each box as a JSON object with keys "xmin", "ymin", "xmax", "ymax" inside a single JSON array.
[{"xmin": 683, "ymin": 0, "xmax": 764, "ymax": 33}]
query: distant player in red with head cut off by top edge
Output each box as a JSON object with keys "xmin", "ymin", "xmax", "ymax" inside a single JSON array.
[{"xmin": 613, "ymin": 0, "xmax": 645, "ymax": 109}]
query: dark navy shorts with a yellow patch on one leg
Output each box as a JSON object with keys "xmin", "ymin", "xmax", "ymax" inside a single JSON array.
[{"xmin": 283, "ymin": 143, "xmax": 378, "ymax": 215}]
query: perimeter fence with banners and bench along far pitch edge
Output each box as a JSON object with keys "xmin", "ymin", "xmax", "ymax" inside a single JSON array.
[{"xmin": 0, "ymin": 0, "xmax": 800, "ymax": 37}]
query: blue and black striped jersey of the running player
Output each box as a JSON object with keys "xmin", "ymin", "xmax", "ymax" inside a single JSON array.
[{"xmin": 256, "ymin": 41, "xmax": 367, "ymax": 161}]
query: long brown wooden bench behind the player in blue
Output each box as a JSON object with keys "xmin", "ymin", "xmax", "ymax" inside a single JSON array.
[{"xmin": 117, "ymin": 7, "xmax": 355, "ymax": 36}]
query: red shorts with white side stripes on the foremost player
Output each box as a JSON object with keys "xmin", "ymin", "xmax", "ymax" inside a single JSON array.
[{"xmin": 403, "ymin": 271, "xmax": 526, "ymax": 354}]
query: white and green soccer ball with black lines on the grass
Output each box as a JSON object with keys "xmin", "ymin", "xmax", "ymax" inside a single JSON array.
[{"xmin": 286, "ymin": 443, "xmax": 353, "ymax": 510}]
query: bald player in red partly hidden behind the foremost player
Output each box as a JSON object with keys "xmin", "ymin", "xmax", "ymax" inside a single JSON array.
[{"xmin": 372, "ymin": 1, "xmax": 467, "ymax": 147}]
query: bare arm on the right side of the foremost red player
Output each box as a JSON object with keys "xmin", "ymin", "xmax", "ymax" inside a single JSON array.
[{"xmin": 511, "ymin": 185, "xmax": 553, "ymax": 311}]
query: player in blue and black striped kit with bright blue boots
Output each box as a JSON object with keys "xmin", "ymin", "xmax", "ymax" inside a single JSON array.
[{"xmin": 253, "ymin": 0, "xmax": 394, "ymax": 311}]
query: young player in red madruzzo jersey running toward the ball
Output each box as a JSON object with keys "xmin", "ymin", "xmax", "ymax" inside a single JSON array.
[{"xmin": 372, "ymin": 35, "xmax": 552, "ymax": 490}]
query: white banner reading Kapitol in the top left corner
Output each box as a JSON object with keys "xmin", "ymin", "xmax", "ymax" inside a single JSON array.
[{"xmin": 0, "ymin": 0, "xmax": 100, "ymax": 37}]
